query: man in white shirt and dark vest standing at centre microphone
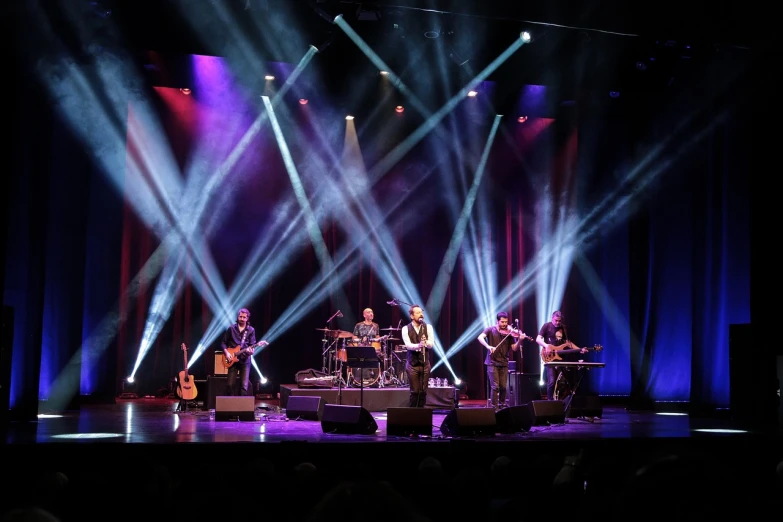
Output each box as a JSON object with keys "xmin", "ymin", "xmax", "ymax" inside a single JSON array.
[{"xmin": 401, "ymin": 305, "xmax": 434, "ymax": 408}]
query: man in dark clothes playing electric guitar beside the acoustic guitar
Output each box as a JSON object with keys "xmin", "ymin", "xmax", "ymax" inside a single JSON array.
[{"xmin": 220, "ymin": 308, "xmax": 269, "ymax": 395}]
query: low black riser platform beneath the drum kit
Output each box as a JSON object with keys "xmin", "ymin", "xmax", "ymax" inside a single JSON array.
[{"xmin": 280, "ymin": 384, "xmax": 455, "ymax": 411}]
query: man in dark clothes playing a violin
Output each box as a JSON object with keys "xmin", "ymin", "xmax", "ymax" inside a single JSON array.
[{"xmin": 477, "ymin": 312, "xmax": 530, "ymax": 411}]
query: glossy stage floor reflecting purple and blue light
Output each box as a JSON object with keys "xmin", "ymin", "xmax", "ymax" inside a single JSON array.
[{"xmin": 4, "ymin": 396, "xmax": 779, "ymax": 445}]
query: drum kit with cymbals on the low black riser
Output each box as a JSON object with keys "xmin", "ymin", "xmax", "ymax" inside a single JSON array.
[{"xmin": 316, "ymin": 327, "xmax": 408, "ymax": 388}]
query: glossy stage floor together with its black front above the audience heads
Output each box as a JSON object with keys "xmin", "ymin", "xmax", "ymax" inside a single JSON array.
[{"xmin": 0, "ymin": 396, "xmax": 783, "ymax": 521}]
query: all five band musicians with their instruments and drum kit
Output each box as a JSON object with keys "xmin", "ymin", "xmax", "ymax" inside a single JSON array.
[{"xmin": 221, "ymin": 298, "xmax": 603, "ymax": 402}]
